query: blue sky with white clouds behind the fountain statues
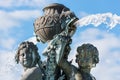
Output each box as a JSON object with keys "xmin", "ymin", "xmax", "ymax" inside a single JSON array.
[{"xmin": 0, "ymin": 0, "xmax": 120, "ymax": 80}]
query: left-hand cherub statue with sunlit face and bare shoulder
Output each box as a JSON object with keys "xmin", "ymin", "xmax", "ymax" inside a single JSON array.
[{"xmin": 15, "ymin": 41, "xmax": 44, "ymax": 80}]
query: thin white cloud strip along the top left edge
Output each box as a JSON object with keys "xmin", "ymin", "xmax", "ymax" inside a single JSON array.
[{"xmin": 0, "ymin": 0, "xmax": 56, "ymax": 8}]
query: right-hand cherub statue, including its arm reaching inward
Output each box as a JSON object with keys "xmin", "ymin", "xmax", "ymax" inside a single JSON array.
[{"xmin": 58, "ymin": 44, "xmax": 99, "ymax": 80}]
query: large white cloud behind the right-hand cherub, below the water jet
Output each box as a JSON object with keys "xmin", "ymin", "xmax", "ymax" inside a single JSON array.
[{"xmin": 70, "ymin": 28, "xmax": 120, "ymax": 80}]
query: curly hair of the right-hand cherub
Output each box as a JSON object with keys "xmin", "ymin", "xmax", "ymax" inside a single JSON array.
[{"xmin": 76, "ymin": 43, "xmax": 99, "ymax": 65}]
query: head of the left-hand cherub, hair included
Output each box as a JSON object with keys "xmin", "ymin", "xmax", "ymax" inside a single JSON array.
[{"xmin": 15, "ymin": 41, "xmax": 40, "ymax": 68}]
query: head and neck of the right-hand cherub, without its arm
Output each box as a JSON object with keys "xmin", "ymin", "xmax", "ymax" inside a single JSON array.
[{"xmin": 76, "ymin": 44, "xmax": 99, "ymax": 80}]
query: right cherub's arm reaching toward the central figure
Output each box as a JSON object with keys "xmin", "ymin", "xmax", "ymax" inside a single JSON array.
[{"xmin": 58, "ymin": 41, "xmax": 82, "ymax": 80}]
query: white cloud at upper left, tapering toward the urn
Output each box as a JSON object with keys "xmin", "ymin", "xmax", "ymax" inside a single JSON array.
[{"xmin": 0, "ymin": 10, "xmax": 41, "ymax": 31}]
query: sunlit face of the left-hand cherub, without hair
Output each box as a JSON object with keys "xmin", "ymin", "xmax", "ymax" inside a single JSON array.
[{"xmin": 19, "ymin": 48, "xmax": 33, "ymax": 67}]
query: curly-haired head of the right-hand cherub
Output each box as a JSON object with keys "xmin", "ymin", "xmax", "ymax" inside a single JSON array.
[{"xmin": 76, "ymin": 44, "xmax": 99, "ymax": 68}]
